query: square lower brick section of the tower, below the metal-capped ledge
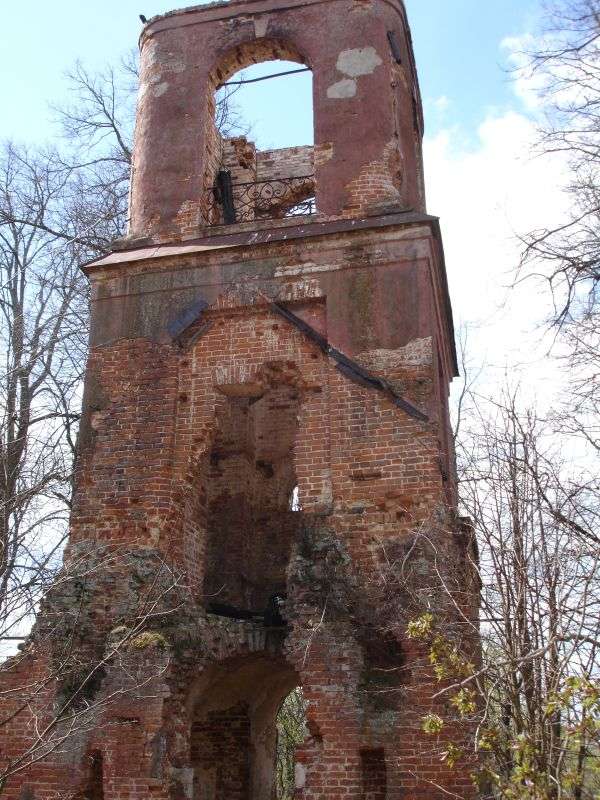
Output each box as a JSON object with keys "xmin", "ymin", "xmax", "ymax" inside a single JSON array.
[{"xmin": 0, "ymin": 138, "xmax": 476, "ymax": 800}]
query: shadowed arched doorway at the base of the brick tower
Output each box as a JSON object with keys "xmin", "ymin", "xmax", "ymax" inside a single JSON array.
[{"xmin": 189, "ymin": 653, "xmax": 299, "ymax": 800}]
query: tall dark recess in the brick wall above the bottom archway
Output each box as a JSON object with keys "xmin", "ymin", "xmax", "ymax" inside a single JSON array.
[{"xmin": 200, "ymin": 384, "xmax": 302, "ymax": 612}]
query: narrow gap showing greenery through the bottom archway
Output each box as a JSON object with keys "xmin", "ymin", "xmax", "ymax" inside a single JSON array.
[{"xmin": 275, "ymin": 686, "xmax": 308, "ymax": 800}]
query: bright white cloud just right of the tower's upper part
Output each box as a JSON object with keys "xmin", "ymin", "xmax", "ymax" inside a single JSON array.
[{"xmin": 425, "ymin": 111, "xmax": 565, "ymax": 394}]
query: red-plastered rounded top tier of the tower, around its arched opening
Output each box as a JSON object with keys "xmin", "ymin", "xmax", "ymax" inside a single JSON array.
[{"xmin": 131, "ymin": 0, "xmax": 425, "ymax": 240}]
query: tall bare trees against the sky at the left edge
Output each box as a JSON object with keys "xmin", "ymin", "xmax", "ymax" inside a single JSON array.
[{"xmin": 0, "ymin": 145, "xmax": 87, "ymax": 638}]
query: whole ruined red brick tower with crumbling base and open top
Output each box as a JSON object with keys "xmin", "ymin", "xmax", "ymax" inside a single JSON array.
[{"xmin": 0, "ymin": 0, "xmax": 475, "ymax": 800}]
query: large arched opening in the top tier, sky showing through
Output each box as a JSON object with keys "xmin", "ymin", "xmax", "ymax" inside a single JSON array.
[{"xmin": 205, "ymin": 40, "xmax": 316, "ymax": 225}]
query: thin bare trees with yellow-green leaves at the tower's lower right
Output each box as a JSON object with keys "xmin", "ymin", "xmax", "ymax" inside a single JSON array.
[{"xmin": 408, "ymin": 390, "xmax": 600, "ymax": 800}]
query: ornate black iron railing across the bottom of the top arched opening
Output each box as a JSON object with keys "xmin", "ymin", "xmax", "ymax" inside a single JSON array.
[{"xmin": 206, "ymin": 171, "xmax": 316, "ymax": 225}]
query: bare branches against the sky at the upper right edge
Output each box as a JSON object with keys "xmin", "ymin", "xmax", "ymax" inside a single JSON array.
[{"xmin": 524, "ymin": 0, "xmax": 600, "ymax": 325}]
